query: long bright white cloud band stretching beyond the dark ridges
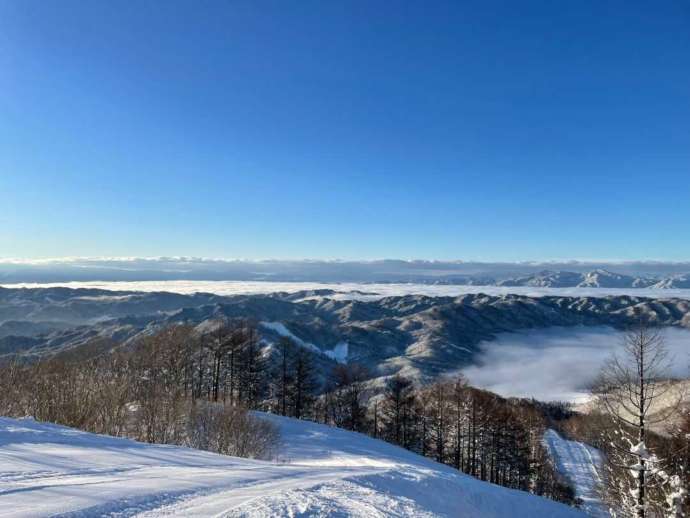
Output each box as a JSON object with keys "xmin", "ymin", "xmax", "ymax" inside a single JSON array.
[{"xmin": 0, "ymin": 281, "xmax": 690, "ymax": 300}]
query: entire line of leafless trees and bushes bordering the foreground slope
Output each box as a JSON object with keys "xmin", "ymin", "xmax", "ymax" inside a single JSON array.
[{"xmin": 0, "ymin": 320, "xmax": 574, "ymax": 504}]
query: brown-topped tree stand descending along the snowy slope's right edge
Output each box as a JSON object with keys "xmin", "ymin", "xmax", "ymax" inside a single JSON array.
[{"xmin": 319, "ymin": 367, "xmax": 574, "ymax": 510}]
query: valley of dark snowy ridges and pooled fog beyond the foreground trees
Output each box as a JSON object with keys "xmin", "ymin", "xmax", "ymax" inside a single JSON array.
[{"xmin": 0, "ymin": 283, "xmax": 690, "ymax": 401}]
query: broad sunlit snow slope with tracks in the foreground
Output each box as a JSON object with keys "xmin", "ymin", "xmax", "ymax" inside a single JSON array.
[{"xmin": 0, "ymin": 416, "xmax": 582, "ymax": 518}]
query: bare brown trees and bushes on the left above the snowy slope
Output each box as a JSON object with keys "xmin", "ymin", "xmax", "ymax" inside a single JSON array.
[{"xmin": 0, "ymin": 324, "xmax": 279, "ymax": 464}]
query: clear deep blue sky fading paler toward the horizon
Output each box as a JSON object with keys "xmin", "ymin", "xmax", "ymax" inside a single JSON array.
[{"xmin": 0, "ymin": 0, "xmax": 690, "ymax": 261}]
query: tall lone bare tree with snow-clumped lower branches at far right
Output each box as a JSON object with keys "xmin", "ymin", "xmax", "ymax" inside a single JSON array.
[{"xmin": 594, "ymin": 322, "xmax": 682, "ymax": 518}]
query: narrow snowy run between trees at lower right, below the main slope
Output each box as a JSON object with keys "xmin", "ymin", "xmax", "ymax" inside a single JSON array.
[{"xmin": 544, "ymin": 429, "xmax": 609, "ymax": 518}]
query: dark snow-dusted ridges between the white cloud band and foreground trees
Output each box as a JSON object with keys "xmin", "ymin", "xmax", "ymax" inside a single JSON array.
[{"xmin": 0, "ymin": 284, "xmax": 690, "ymax": 386}]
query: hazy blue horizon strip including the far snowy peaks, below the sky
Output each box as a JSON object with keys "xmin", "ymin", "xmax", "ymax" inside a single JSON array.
[{"xmin": 0, "ymin": 257, "xmax": 690, "ymax": 288}]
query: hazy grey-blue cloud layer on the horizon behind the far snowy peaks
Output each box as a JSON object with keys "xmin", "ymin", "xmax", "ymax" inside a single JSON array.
[{"xmin": 0, "ymin": 257, "xmax": 690, "ymax": 283}]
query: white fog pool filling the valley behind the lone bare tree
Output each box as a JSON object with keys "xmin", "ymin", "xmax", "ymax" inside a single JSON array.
[{"xmin": 463, "ymin": 327, "xmax": 690, "ymax": 401}]
